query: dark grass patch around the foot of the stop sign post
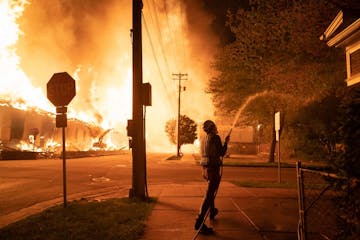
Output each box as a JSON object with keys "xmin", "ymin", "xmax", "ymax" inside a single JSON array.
[{"xmin": 0, "ymin": 198, "xmax": 155, "ymax": 240}]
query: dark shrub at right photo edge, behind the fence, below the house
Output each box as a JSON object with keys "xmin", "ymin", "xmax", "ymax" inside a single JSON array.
[{"xmin": 329, "ymin": 89, "xmax": 360, "ymax": 239}]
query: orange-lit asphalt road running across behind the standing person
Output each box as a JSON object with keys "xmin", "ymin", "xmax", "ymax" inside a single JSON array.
[{"xmin": 0, "ymin": 152, "xmax": 296, "ymax": 216}]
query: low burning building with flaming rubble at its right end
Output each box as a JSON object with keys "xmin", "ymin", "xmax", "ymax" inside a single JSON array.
[{"xmin": 0, "ymin": 102, "xmax": 125, "ymax": 159}]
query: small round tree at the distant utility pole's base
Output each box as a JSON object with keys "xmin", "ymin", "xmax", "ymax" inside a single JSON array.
[{"xmin": 165, "ymin": 115, "xmax": 197, "ymax": 151}]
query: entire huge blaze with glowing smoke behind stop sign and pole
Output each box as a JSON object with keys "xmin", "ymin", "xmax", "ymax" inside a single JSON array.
[{"xmin": 0, "ymin": 0, "xmax": 215, "ymax": 152}]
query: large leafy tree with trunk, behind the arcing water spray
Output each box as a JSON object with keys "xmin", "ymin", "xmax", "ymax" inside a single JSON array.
[{"xmin": 208, "ymin": 0, "xmax": 345, "ymax": 161}]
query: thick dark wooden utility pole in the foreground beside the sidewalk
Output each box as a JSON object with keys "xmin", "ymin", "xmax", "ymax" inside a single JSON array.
[{"xmin": 128, "ymin": 0, "xmax": 146, "ymax": 199}]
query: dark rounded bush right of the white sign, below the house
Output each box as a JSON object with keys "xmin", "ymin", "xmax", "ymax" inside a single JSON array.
[{"xmin": 284, "ymin": 96, "xmax": 342, "ymax": 161}]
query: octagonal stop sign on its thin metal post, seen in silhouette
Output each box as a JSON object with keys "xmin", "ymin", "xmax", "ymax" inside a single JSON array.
[{"xmin": 46, "ymin": 72, "xmax": 76, "ymax": 208}]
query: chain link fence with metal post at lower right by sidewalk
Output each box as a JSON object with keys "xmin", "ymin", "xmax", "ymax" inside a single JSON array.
[{"xmin": 296, "ymin": 162, "xmax": 342, "ymax": 240}]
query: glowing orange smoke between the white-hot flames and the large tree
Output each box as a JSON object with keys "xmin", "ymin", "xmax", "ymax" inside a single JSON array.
[{"xmin": 17, "ymin": 0, "xmax": 218, "ymax": 151}]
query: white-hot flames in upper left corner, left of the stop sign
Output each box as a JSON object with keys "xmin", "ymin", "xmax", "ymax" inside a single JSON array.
[{"xmin": 0, "ymin": 0, "xmax": 51, "ymax": 110}]
